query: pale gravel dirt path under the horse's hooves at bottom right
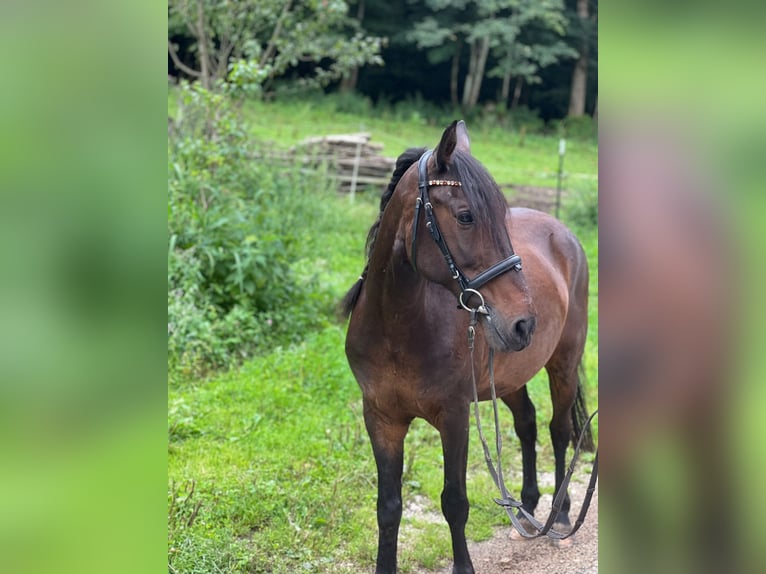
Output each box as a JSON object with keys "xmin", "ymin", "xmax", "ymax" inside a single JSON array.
[{"xmin": 417, "ymin": 473, "xmax": 598, "ymax": 574}]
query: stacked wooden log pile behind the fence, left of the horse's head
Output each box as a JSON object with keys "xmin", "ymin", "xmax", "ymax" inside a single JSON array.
[{"xmin": 291, "ymin": 133, "xmax": 396, "ymax": 193}]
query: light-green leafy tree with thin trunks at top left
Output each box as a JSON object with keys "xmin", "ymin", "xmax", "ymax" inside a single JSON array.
[{"xmin": 168, "ymin": 0, "xmax": 383, "ymax": 90}]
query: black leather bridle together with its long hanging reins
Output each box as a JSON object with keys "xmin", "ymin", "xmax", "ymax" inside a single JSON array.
[{"xmin": 411, "ymin": 150, "xmax": 598, "ymax": 540}]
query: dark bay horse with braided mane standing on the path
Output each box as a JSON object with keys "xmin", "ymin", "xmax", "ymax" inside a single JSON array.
[{"xmin": 343, "ymin": 121, "xmax": 592, "ymax": 574}]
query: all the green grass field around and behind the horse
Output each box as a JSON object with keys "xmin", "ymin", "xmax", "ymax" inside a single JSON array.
[{"xmin": 168, "ymin": 95, "xmax": 598, "ymax": 573}]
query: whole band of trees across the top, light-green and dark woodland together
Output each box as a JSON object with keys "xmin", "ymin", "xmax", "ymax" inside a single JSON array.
[{"xmin": 168, "ymin": 0, "xmax": 598, "ymax": 118}]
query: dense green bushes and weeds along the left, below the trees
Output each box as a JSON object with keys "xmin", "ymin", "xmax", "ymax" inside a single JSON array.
[{"xmin": 168, "ymin": 86, "xmax": 344, "ymax": 382}]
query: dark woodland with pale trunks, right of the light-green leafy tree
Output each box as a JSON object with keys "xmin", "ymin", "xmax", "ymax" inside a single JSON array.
[{"xmin": 358, "ymin": 0, "xmax": 598, "ymax": 118}]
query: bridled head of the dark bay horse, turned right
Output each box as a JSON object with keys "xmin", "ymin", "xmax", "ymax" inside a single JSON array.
[{"xmin": 402, "ymin": 121, "xmax": 536, "ymax": 351}]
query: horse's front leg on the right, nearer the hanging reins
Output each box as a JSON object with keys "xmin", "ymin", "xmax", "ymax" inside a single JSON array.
[{"xmin": 439, "ymin": 404, "xmax": 474, "ymax": 574}]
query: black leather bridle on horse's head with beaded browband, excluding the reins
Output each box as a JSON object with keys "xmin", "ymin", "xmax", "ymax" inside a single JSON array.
[{"xmin": 411, "ymin": 150, "xmax": 521, "ymax": 313}]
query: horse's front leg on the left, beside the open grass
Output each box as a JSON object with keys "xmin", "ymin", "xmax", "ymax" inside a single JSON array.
[{"xmin": 364, "ymin": 401, "xmax": 411, "ymax": 574}]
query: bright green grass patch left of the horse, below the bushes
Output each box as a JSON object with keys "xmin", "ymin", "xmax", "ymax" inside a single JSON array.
[{"xmin": 169, "ymin": 327, "xmax": 374, "ymax": 572}]
